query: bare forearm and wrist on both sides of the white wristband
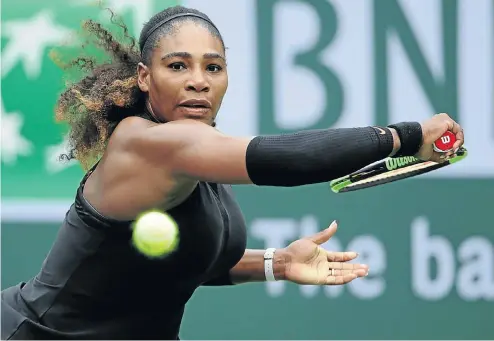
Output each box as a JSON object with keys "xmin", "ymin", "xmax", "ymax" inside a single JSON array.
[{"xmin": 230, "ymin": 249, "xmax": 289, "ymax": 284}]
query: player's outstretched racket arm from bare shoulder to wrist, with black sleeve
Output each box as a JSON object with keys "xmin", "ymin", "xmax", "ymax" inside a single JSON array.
[{"xmin": 127, "ymin": 120, "xmax": 412, "ymax": 187}]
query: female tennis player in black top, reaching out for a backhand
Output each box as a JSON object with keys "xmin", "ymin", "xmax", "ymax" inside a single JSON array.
[{"xmin": 2, "ymin": 3, "xmax": 463, "ymax": 340}]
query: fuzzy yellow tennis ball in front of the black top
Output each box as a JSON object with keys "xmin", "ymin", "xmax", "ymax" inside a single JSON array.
[{"xmin": 132, "ymin": 211, "xmax": 179, "ymax": 258}]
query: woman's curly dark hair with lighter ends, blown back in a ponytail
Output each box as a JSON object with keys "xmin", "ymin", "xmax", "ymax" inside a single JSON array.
[{"xmin": 52, "ymin": 6, "xmax": 225, "ymax": 170}]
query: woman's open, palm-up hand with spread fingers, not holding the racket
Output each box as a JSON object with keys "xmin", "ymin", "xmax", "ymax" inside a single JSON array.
[{"xmin": 285, "ymin": 221, "xmax": 369, "ymax": 285}]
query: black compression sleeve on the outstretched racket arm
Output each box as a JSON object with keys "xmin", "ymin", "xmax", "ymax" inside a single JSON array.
[{"xmin": 246, "ymin": 127, "xmax": 393, "ymax": 187}]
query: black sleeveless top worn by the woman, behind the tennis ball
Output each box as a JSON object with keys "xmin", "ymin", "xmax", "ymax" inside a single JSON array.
[{"xmin": 2, "ymin": 164, "xmax": 246, "ymax": 340}]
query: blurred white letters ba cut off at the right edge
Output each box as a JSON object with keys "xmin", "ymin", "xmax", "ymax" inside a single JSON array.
[{"xmin": 411, "ymin": 217, "xmax": 494, "ymax": 301}]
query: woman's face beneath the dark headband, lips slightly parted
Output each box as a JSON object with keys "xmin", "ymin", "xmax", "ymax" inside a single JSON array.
[{"xmin": 138, "ymin": 21, "xmax": 228, "ymax": 125}]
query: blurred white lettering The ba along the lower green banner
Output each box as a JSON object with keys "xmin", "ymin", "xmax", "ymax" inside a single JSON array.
[{"xmin": 250, "ymin": 215, "xmax": 494, "ymax": 301}]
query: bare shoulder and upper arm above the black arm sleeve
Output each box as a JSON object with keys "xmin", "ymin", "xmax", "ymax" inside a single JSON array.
[{"xmin": 108, "ymin": 117, "xmax": 251, "ymax": 183}]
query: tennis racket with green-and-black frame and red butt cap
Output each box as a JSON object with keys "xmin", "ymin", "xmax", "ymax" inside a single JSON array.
[{"xmin": 330, "ymin": 132, "xmax": 468, "ymax": 193}]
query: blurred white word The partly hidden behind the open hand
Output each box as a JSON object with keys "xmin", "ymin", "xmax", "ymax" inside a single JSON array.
[{"xmin": 251, "ymin": 216, "xmax": 386, "ymax": 299}]
